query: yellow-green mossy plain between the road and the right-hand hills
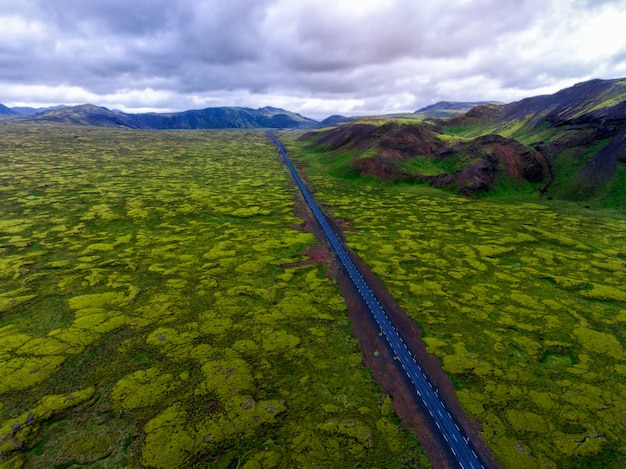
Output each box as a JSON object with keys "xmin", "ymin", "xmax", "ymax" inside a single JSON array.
[{"xmin": 281, "ymin": 133, "xmax": 626, "ymax": 469}]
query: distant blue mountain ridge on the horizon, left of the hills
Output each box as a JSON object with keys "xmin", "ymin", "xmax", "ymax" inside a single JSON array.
[{"xmin": 23, "ymin": 104, "xmax": 317, "ymax": 130}]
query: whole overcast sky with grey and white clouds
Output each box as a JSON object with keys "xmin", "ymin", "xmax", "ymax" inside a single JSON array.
[{"xmin": 0, "ymin": 0, "xmax": 626, "ymax": 119}]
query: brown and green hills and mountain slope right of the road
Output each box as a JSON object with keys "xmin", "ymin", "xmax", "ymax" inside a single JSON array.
[{"xmin": 303, "ymin": 80, "xmax": 626, "ymax": 210}]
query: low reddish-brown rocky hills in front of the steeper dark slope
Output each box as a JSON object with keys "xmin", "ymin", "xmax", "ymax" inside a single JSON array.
[{"xmin": 303, "ymin": 122, "xmax": 548, "ymax": 195}]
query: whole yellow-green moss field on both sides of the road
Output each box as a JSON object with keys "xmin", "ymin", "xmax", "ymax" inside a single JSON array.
[{"xmin": 0, "ymin": 123, "xmax": 424, "ymax": 469}]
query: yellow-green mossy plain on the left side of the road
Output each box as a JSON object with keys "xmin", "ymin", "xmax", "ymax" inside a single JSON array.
[{"xmin": 0, "ymin": 124, "xmax": 429, "ymax": 469}]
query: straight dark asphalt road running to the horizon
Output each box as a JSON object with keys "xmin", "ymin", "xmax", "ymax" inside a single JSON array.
[{"xmin": 267, "ymin": 131, "xmax": 484, "ymax": 469}]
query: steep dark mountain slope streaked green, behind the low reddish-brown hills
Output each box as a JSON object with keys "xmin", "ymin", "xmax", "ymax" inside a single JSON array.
[{"xmin": 442, "ymin": 79, "xmax": 626, "ymax": 203}]
